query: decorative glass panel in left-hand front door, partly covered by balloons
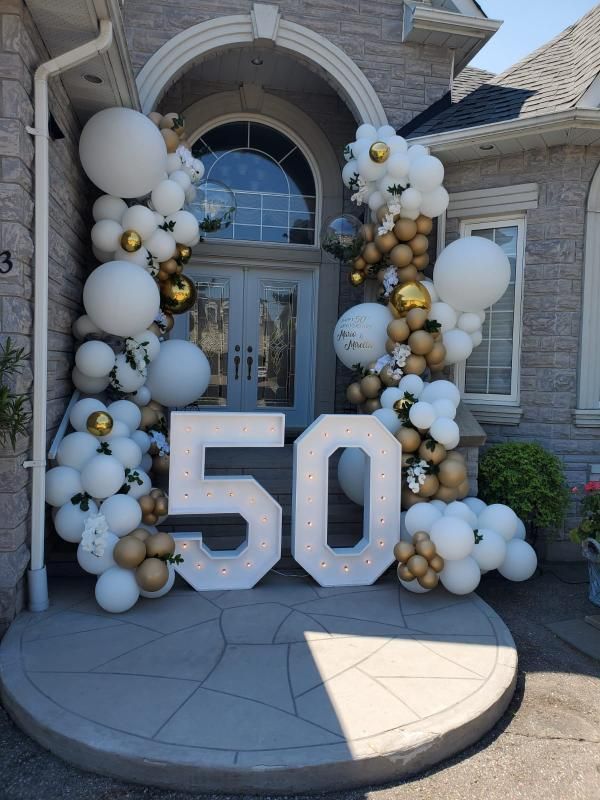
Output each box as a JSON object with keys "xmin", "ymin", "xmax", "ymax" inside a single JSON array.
[{"xmin": 189, "ymin": 278, "xmax": 230, "ymax": 406}]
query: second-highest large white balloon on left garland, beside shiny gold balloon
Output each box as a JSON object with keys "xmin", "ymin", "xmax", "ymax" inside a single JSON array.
[{"xmin": 83, "ymin": 261, "xmax": 160, "ymax": 336}]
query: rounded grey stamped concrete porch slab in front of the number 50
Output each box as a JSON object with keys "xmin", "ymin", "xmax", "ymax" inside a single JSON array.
[{"xmin": 0, "ymin": 574, "xmax": 517, "ymax": 793}]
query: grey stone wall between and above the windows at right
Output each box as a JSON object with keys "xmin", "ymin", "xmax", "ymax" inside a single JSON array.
[{"xmin": 445, "ymin": 146, "xmax": 600, "ymax": 553}]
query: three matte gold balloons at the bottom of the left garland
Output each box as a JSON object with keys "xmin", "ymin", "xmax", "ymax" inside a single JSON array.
[{"xmin": 113, "ymin": 528, "xmax": 175, "ymax": 592}]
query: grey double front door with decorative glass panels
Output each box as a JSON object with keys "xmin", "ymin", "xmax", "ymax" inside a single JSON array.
[{"xmin": 174, "ymin": 266, "xmax": 315, "ymax": 427}]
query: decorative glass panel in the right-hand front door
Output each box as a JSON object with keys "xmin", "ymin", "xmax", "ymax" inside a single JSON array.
[{"xmin": 257, "ymin": 281, "xmax": 298, "ymax": 408}]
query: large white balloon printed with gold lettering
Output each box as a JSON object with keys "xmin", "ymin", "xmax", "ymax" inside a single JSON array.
[{"xmin": 330, "ymin": 303, "xmax": 392, "ymax": 372}]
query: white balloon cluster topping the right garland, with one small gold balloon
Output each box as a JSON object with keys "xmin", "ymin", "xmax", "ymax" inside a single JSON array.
[{"xmin": 342, "ymin": 124, "xmax": 448, "ymax": 219}]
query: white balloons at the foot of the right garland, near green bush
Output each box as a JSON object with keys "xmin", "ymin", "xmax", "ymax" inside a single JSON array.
[{"xmin": 400, "ymin": 497, "xmax": 537, "ymax": 594}]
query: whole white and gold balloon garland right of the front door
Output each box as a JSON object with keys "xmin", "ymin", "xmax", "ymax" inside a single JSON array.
[{"xmin": 332, "ymin": 120, "xmax": 537, "ymax": 594}]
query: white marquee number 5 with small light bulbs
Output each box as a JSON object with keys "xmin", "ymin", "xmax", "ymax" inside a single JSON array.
[{"xmin": 169, "ymin": 411, "xmax": 285, "ymax": 591}]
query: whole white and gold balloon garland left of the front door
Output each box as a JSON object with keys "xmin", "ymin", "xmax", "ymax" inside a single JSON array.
[{"xmin": 46, "ymin": 108, "xmax": 235, "ymax": 613}]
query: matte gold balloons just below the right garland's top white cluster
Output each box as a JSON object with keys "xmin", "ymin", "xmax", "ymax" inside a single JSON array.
[{"xmin": 350, "ymin": 212, "xmax": 433, "ymax": 286}]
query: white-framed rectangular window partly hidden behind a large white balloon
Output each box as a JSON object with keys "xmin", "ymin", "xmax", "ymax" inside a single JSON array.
[{"xmin": 456, "ymin": 217, "xmax": 525, "ymax": 405}]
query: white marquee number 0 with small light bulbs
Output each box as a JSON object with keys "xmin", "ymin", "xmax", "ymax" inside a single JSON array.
[{"xmin": 292, "ymin": 414, "xmax": 402, "ymax": 586}]
